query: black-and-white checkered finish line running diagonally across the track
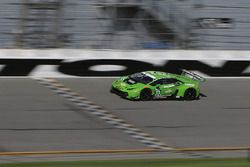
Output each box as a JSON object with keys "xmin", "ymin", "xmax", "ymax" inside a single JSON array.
[{"xmin": 34, "ymin": 78, "xmax": 172, "ymax": 151}]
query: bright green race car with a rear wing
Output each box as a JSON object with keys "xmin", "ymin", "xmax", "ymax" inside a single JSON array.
[{"xmin": 111, "ymin": 70, "xmax": 205, "ymax": 100}]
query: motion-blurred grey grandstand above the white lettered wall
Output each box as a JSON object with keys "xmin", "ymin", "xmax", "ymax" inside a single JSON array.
[{"xmin": 0, "ymin": 0, "xmax": 250, "ymax": 50}]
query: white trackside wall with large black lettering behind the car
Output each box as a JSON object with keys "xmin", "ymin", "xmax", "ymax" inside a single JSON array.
[{"xmin": 0, "ymin": 49, "xmax": 250, "ymax": 77}]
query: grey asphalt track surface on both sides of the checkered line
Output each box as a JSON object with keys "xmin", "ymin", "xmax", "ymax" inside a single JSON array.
[{"xmin": 0, "ymin": 78, "xmax": 250, "ymax": 162}]
